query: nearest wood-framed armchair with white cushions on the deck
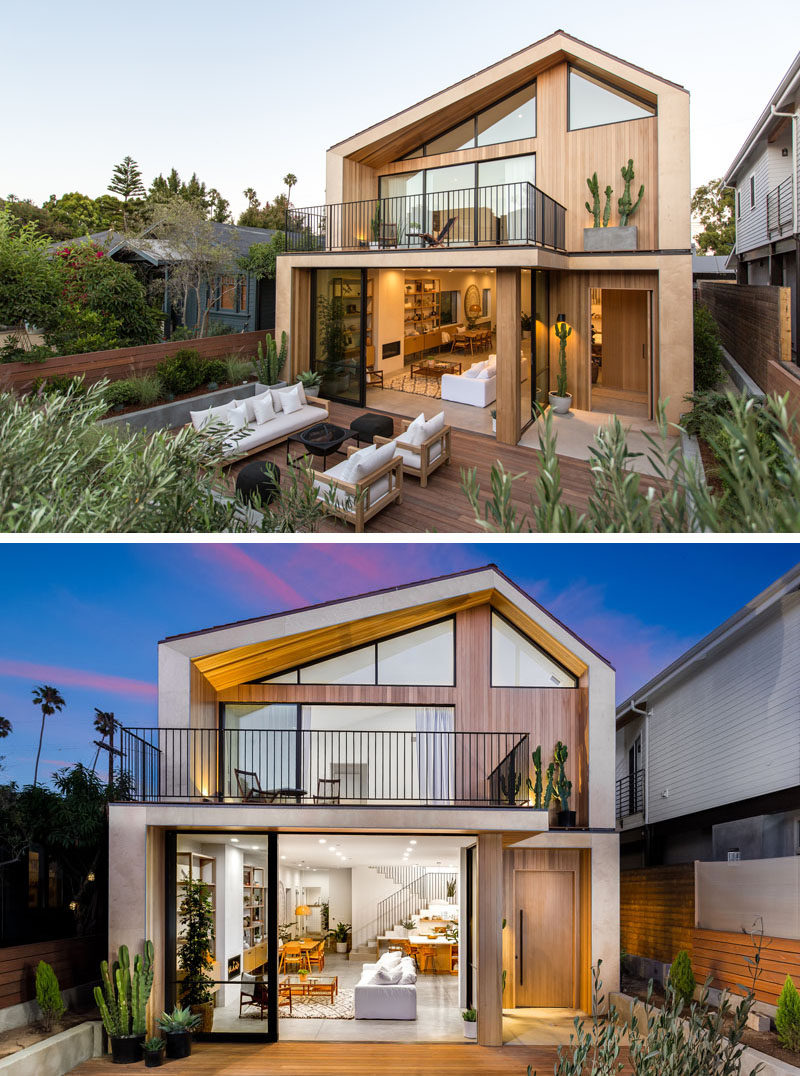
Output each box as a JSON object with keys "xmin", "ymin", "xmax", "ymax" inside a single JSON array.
[{"xmin": 312, "ymin": 437, "xmax": 404, "ymax": 534}]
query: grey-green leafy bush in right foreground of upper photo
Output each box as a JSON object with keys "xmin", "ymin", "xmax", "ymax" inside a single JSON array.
[{"xmin": 461, "ymin": 394, "xmax": 800, "ymax": 534}]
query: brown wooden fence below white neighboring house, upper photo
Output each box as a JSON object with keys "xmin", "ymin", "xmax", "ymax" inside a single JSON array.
[{"xmin": 698, "ymin": 280, "xmax": 791, "ymax": 391}]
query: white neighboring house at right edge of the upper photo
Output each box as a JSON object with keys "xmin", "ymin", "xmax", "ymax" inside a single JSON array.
[{"xmin": 725, "ymin": 53, "xmax": 800, "ymax": 360}]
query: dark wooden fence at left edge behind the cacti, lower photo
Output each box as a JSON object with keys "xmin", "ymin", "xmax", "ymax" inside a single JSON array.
[{"xmin": 0, "ymin": 935, "xmax": 107, "ymax": 1008}]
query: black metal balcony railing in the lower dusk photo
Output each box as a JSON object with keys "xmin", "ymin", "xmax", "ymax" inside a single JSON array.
[{"xmin": 116, "ymin": 727, "xmax": 528, "ymax": 807}]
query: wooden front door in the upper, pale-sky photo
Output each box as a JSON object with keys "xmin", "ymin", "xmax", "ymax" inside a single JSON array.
[{"xmin": 602, "ymin": 287, "xmax": 650, "ymax": 397}]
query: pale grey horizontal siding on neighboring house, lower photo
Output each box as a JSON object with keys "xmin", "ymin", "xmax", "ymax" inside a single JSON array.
[{"xmin": 647, "ymin": 594, "xmax": 800, "ymax": 823}]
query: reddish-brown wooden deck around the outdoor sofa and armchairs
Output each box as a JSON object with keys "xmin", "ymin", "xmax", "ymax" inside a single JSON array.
[{"xmin": 228, "ymin": 404, "xmax": 591, "ymax": 534}]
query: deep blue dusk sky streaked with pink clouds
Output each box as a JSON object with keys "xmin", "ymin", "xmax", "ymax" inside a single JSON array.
[{"xmin": 0, "ymin": 541, "xmax": 800, "ymax": 782}]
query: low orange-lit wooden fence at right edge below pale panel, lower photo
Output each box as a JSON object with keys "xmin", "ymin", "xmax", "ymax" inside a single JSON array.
[{"xmin": 691, "ymin": 930, "xmax": 800, "ymax": 1005}]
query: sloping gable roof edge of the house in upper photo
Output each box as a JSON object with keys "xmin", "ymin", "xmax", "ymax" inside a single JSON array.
[{"xmin": 328, "ymin": 30, "xmax": 688, "ymax": 162}]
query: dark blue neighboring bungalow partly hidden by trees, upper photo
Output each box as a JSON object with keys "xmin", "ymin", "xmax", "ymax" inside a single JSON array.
[{"xmin": 51, "ymin": 227, "xmax": 276, "ymax": 332}]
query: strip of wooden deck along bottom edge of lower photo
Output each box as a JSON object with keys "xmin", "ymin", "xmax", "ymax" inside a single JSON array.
[{"xmin": 71, "ymin": 1042, "xmax": 630, "ymax": 1076}]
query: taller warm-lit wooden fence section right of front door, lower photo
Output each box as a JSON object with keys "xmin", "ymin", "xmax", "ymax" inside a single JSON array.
[{"xmin": 619, "ymin": 863, "xmax": 694, "ymax": 964}]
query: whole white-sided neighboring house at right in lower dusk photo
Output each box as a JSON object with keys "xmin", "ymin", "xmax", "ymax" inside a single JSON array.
[{"xmin": 616, "ymin": 566, "xmax": 800, "ymax": 868}]
